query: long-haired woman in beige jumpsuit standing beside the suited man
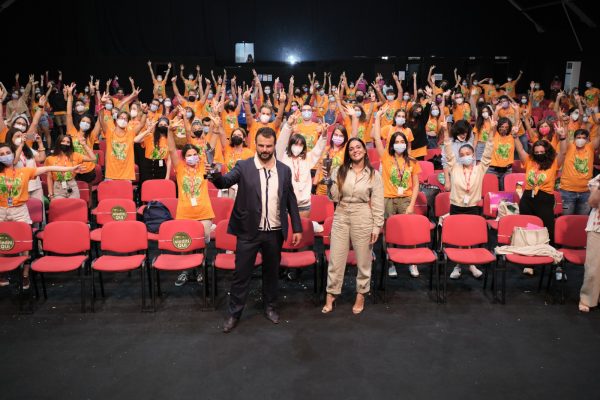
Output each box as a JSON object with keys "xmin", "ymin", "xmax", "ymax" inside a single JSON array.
[{"xmin": 322, "ymin": 138, "xmax": 384, "ymax": 314}]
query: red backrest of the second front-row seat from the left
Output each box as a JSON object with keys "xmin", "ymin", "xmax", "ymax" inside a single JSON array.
[{"xmin": 43, "ymin": 220, "xmax": 90, "ymax": 255}]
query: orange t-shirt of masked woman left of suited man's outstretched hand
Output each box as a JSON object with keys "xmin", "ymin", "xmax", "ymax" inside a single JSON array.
[{"xmin": 175, "ymin": 161, "xmax": 215, "ymax": 221}]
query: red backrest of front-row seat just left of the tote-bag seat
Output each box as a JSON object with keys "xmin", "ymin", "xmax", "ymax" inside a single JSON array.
[{"xmin": 442, "ymin": 215, "xmax": 487, "ymax": 247}]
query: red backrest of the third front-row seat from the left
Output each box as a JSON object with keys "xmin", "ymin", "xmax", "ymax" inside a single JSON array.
[{"xmin": 100, "ymin": 220, "xmax": 148, "ymax": 253}]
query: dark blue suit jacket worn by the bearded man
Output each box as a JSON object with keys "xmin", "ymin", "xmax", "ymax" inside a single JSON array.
[{"xmin": 213, "ymin": 157, "xmax": 302, "ymax": 240}]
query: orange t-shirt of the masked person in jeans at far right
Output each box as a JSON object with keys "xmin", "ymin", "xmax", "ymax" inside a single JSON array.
[{"xmin": 560, "ymin": 143, "xmax": 594, "ymax": 192}]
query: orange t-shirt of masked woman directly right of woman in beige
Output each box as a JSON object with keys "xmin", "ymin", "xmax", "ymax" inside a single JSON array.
[{"xmin": 381, "ymin": 152, "xmax": 421, "ymax": 199}]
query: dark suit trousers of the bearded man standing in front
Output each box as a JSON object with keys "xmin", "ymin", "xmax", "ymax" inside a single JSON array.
[{"xmin": 229, "ymin": 230, "xmax": 283, "ymax": 318}]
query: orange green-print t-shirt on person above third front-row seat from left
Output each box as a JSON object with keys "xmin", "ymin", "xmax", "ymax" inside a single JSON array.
[{"xmin": 104, "ymin": 121, "xmax": 135, "ymax": 181}]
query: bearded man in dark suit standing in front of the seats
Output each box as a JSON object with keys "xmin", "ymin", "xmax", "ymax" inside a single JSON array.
[{"xmin": 213, "ymin": 127, "xmax": 302, "ymax": 333}]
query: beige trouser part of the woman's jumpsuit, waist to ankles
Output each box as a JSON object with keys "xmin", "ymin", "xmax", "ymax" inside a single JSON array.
[{"xmin": 327, "ymin": 203, "xmax": 373, "ymax": 295}]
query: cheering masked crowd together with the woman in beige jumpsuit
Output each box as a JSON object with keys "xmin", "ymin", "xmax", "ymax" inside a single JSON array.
[{"xmin": 0, "ymin": 62, "xmax": 600, "ymax": 313}]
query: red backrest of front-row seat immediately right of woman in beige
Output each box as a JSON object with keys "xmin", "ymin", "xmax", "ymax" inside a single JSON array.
[{"xmin": 385, "ymin": 214, "xmax": 431, "ymax": 246}]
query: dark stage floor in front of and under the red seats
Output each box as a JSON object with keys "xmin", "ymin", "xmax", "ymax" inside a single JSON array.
[{"xmin": 0, "ymin": 256, "xmax": 600, "ymax": 400}]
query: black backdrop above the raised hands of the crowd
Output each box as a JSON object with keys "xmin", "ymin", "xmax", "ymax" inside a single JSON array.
[{"xmin": 0, "ymin": 0, "xmax": 600, "ymax": 98}]
